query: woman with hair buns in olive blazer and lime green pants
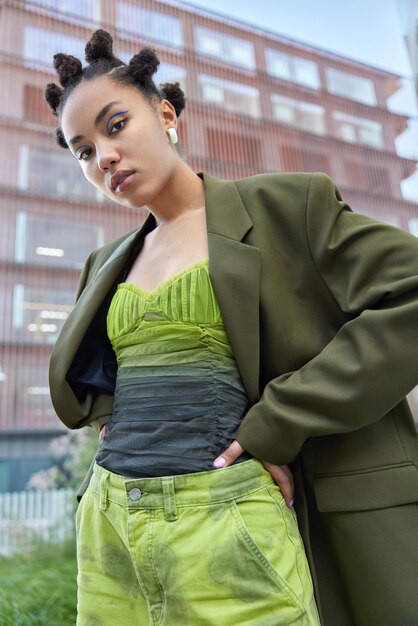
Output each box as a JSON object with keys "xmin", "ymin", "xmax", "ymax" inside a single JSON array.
[{"xmin": 46, "ymin": 31, "xmax": 418, "ymax": 626}]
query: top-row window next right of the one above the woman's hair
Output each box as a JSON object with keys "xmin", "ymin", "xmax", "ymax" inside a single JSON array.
[{"xmin": 195, "ymin": 26, "xmax": 255, "ymax": 70}]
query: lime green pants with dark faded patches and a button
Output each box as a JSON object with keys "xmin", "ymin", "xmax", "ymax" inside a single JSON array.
[{"xmin": 76, "ymin": 459, "xmax": 319, "ymax": 626}]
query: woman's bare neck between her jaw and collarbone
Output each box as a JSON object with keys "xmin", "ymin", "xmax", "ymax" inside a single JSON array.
[{"xmin": 148, "ymin": 162, "xmax": 205, "ymax": 226}]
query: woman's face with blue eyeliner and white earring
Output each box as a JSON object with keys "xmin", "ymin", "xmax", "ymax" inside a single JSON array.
[{"xmin": 61, "ymin": 77, "xmax": 179, "ymax": 208}]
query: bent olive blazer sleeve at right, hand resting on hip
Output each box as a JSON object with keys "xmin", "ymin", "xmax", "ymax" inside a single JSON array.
[{"xmin": 237, "ymin": 174, "xmax": 418, "ymax": 463}]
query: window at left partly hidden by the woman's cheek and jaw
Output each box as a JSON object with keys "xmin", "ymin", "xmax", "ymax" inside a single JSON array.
[{"xmin": 18, "ymin": 145, "xmax": 103, "ymax": 202}]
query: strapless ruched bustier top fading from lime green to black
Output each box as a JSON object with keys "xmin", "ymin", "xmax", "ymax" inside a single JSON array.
[{"xmin": 97, "ymin": 260, "xmax": 248, "ymax": 477}]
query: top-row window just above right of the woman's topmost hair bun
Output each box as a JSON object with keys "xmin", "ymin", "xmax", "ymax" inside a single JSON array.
[{"xmin": 117, "ymin": 2, "xmax": 183, "ymax": 48}]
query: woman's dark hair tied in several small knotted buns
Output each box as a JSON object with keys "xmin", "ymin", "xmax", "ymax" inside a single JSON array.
[{"xmin": 45, "ymin": 29, "xmax": 185, "ymax": 148}]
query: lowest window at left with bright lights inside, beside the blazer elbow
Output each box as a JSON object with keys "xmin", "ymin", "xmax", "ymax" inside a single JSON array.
[{"xmin": 13, "ymin": 284, "xmax": 74, "ymax": 344}]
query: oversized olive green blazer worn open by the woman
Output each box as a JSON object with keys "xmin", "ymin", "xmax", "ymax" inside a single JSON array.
[{"xmin": 50, "ymin": 174, "xmax": 418, "ymax": 626}]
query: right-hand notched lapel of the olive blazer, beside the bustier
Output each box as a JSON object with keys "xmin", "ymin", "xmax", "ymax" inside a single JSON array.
[{"xmin": 202, "ymin": 174, "xmax": 261, "ymax": 403}]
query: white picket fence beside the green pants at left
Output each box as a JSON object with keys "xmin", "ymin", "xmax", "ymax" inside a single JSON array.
[{"xmin": 0, "ymin": 489, "xmax": 76, "ymax": 556}]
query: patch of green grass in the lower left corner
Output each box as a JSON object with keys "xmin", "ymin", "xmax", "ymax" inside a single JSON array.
[{"xmin": 0, "ymin": 539, "xmax": 76, "ymax": 626}]
